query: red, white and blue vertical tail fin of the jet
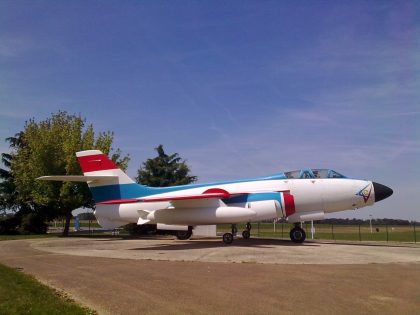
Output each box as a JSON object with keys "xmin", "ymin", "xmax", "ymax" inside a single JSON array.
[{"xmin": 76, "ymin": 150, "xmax": 148, "ymax": 202}]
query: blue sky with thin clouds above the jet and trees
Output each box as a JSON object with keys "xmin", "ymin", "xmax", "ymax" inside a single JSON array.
[{"xmin": 0, "ymin": 0, "xmax": 420, "ymax": 220}]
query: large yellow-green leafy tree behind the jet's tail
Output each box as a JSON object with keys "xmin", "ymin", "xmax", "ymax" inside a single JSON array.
[{"xmin": 11, "ymin": 111, "xmax": 129, "ymax": 235}]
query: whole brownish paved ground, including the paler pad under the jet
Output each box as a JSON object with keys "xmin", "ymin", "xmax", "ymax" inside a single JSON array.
[{"xmin": 0, "ymin": 238, "xmax": 420, "ymax": 314}]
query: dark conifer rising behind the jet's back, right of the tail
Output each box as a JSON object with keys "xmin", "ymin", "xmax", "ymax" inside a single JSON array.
[{"xmin": 136, "ymin": 144, "xmax": 197, "ymax": 187}]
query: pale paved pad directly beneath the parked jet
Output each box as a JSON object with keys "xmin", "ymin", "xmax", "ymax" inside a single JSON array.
[{"xmin": 31, "ymin": 238, "xmax": 420, "ymax": 265}]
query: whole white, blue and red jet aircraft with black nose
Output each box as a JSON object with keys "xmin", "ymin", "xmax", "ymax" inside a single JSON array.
[{"xmin": 39, "ymin": 150, "xmax": 393, "ymax": 244}]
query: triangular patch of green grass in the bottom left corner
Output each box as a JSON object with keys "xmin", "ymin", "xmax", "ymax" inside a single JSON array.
[{"xmin": 0, "ymin": 265, "xmax": 96, "ymax": 315}]
